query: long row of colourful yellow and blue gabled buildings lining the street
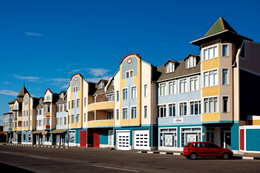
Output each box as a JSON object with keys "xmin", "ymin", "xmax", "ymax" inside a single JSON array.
[{"xmin": 4, "ymin": 17, "xmax": 260, "ymax": 152}]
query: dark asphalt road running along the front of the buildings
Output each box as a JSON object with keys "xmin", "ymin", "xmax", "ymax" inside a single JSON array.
[{"xmin": 0, "ymin": 145, "xmax": 260, "ymax": 173}]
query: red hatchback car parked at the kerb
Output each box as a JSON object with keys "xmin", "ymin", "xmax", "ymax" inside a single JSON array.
[{"xmin": 182, "ymin": 142, "xmax": 233, "ymax": 160}]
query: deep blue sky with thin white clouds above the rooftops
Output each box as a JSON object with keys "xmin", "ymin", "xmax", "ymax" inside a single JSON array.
[{"xmin": 0, "ymin": 0, "xmax": 260, "ymax": 124}]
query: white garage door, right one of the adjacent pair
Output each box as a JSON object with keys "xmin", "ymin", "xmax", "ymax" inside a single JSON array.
[{"xmin": 134, "ymin": 130, "xmax": 149, "ymax": 150}]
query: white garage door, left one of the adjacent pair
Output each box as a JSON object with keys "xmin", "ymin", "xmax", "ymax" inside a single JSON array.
[{"xmin": 116, "ymin": 131, "xmax": 131, "ymax": 150}]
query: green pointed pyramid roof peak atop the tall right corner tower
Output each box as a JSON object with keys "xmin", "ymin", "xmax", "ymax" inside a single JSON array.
[{"xmin": 204, "ymin": 17, "xmax": 236, "ymax": 37}]
